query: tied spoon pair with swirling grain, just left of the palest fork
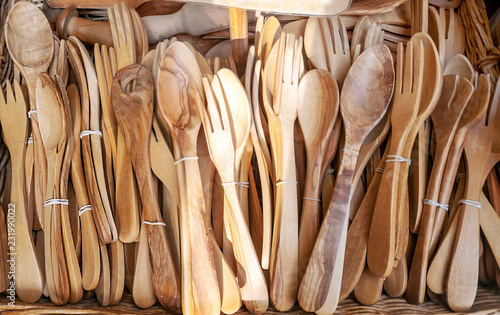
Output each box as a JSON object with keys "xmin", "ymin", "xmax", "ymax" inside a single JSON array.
[{"xmin": 157, "ymin": 42, "xmax": 221, "ymax": 314}]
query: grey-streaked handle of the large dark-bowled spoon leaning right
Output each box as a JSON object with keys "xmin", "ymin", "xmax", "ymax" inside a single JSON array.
[{"xmin": 298, "ymin": 147, "xmax": 359, "ymax": 313}]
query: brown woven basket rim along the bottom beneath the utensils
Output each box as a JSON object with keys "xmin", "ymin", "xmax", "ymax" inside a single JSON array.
[{"xmin": 0, "ymin": 287, "xmax": 500, "ymax": 315}]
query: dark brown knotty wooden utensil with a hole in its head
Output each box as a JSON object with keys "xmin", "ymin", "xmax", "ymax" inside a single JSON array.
[{"xmin": 111, "ymin": 65, "xmax": 181, "ymax": 312}]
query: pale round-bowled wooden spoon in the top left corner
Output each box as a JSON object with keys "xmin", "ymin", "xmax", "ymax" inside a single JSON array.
[{"xmin": 5, "ymin": 1, "xmax": 54, "ymax": 235}]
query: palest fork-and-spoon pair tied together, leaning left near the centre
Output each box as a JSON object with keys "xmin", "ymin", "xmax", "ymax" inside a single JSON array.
[{"xmin": 199, "ymin": 69, "xmax": 269, "ymax": 313}]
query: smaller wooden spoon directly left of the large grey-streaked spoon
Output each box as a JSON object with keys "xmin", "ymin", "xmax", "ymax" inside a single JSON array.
[{"xmin": 298, "ymin": 70, "xmax": 339, "ymax": 278}]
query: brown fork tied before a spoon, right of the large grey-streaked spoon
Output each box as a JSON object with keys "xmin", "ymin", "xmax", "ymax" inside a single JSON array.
[{"xmin": 367, "ymin": 41, "xmax": 425, "ymax": 277}]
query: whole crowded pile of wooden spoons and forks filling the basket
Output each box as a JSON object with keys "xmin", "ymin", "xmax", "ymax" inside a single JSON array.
[{"xmin": 0, "ymin": 0, "xmax": 500, "ymax": 314}]
